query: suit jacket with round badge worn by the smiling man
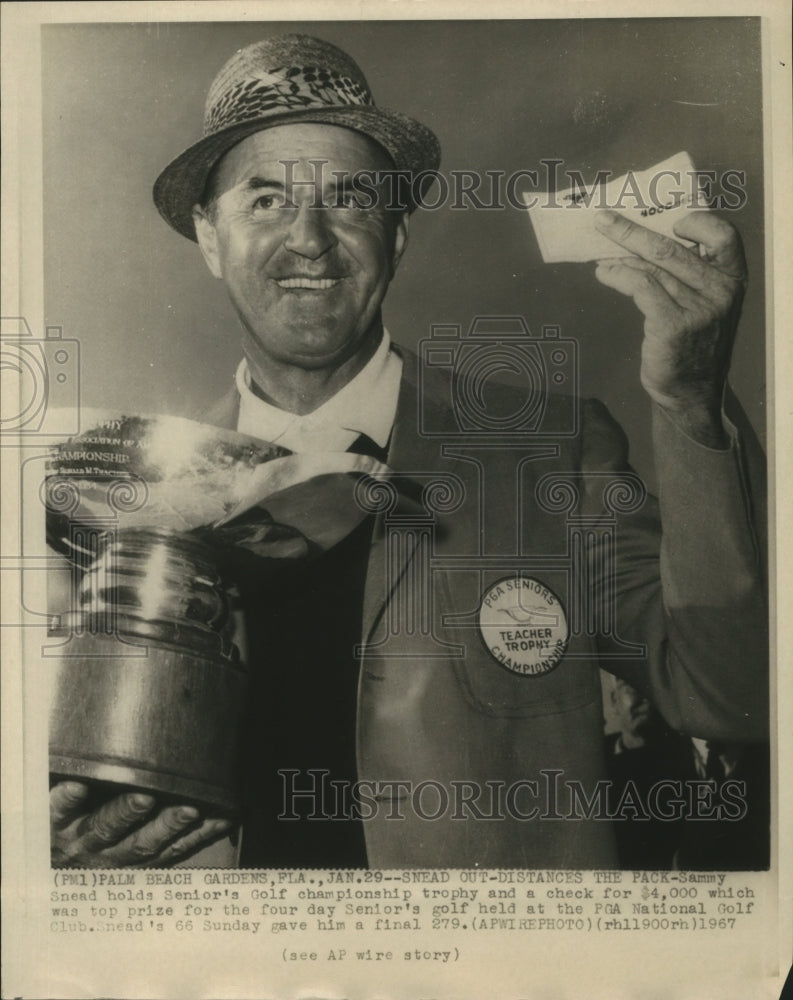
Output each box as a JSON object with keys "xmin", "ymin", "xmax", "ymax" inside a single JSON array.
[{"xmin": 203, "ymin": 349, "xmax": 767, "ymax": 868}]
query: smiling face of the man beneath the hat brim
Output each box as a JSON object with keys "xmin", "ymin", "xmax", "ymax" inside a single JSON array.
[{"xmin": 189, "ymin": 124, "xmax": 406, "ymax": 378}]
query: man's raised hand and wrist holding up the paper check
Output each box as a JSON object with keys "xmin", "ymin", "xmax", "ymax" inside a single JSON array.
[{"xmin": 595, "ymin": 211, "xmax": 746, "ymax": 448}]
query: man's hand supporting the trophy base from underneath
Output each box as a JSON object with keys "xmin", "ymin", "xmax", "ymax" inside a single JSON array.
[{"xmin": 50, "ymin": 781, "xmax": 231, "ymax": 868}]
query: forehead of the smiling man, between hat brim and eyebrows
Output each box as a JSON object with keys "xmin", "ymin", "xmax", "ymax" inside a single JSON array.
[{"xmin": 216, "ymin": 122, "xmax": 393, "ymax": 187}]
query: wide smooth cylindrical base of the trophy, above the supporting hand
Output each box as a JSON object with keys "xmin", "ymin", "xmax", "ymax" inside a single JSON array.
[{"xmin": 49, "ymin": 631, "xmax": 247, "ymax": 815}]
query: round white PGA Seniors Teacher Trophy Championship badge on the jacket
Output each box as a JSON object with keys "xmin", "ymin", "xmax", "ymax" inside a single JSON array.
[{"xmin": 479, "ymin": 576, "xmax": 568, "ymax": 677}]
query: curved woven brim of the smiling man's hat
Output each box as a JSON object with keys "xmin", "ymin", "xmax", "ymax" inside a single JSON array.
[{"xmin": 153, "ymin": 105, "xmax": 441, "ymax": 241}]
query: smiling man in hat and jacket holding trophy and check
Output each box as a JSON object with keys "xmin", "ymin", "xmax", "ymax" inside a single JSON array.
[{"xmin": 52, "ymin": 36, "xmax": 766, "ymax": 868}]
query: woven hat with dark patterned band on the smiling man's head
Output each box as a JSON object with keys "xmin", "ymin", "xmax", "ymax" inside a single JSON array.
[{"xmin": 154, "ymin": 35, "xmax": 440, "ymax": 240}]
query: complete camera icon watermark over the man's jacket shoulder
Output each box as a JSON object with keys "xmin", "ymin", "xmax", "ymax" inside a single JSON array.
[{"xmin": 419, "ymin": 316, "xmax": 579, "ymax": 440}]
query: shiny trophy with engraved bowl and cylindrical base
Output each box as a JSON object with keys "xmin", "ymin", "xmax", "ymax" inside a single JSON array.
[{"xmin": 45, "ymin": 411, "xmax": 388, "ymax": 815}]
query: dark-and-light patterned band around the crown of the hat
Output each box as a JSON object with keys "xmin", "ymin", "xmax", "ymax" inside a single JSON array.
[{"xmin": 204, "ymin": 66, "xmax": 374, "ymax": 135}]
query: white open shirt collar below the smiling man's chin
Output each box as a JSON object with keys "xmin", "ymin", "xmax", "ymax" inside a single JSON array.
[{"xmin": 236, "ymin": 330, "xmax": 402, "ymax": 452}]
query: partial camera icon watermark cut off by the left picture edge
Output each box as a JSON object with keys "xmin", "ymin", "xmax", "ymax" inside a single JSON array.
[{"xmin": 0, "ymin": 316, "xmax": 80, "ymax": 445}]
